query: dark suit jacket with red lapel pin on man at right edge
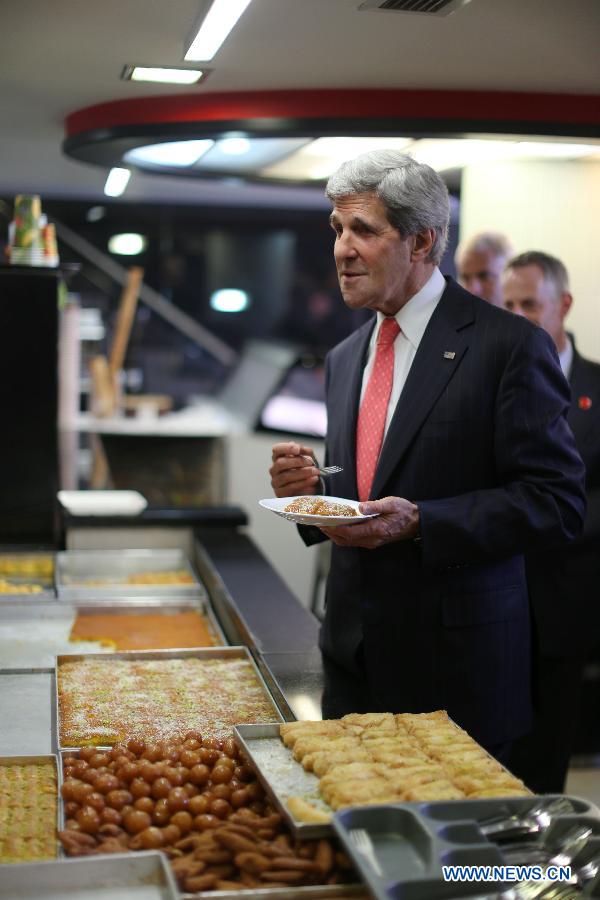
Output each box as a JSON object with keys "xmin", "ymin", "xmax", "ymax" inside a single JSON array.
[{"xmin": 527, "ymin": 337, "xmax": 600, "ymax": 657}]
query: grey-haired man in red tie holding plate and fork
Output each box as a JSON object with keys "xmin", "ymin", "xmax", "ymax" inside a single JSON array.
[{"xmin": 270, "ymin": 151, "xmax": 584, "ymax": 756}]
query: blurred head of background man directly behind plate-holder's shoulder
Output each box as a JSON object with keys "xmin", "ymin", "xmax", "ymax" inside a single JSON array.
[{"xmin": 454, "ymin": 231, "xmax": 514, "ymax": 306}]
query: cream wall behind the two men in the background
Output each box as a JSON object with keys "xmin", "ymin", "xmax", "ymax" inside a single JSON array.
[{"xmin": 460, "ymin": 160, "xmax": 600, "ymax": 360}]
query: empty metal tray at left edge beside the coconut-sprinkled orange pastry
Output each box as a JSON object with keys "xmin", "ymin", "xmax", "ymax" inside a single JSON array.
[{"xmin": 0, "ymin": 669, "xmax": 55, "ymax": 755}]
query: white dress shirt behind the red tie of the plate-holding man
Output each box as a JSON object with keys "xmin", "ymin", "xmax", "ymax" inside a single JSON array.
[{"xmin": 360, "ymin": 268, "xmax": 446, "ymax": 438}]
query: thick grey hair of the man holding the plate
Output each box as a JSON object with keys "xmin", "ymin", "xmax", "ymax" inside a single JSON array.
[{"xmin": 325, "ymin": 150, "xmax": 450, "ymax": 265}]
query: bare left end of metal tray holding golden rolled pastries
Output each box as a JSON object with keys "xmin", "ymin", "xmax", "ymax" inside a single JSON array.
[{"xmin": 233, "ymin": 725, "xmax": 333, "ymax": 838}]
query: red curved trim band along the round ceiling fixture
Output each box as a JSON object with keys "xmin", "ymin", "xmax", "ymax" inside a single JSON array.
[{"xmin": 65, "ymin": 89, "xmax": 600, "ymax": 137}]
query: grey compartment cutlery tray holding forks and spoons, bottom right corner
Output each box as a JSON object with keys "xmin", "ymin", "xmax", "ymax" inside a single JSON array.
[{"xmin": 333, "ymin": 795, "xmax": 600, "ymax": 900}]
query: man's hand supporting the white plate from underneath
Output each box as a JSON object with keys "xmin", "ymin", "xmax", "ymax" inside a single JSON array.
[{"xmin": 319, "ymin": 497, "xmax": 419, "ymax": 550}]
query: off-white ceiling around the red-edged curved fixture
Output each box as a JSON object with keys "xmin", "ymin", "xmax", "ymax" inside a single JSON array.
[{"xmin": 0, "ymin": 0, "xmax": 600, "ymax": 206}]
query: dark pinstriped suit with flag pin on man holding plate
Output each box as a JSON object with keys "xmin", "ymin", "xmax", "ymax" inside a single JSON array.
[{"xmin": 303, "ymin": 279, "xmax": 585, "ymax": 745}]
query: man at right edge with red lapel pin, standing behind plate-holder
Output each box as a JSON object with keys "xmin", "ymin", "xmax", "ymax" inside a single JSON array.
[{"xmin": 503, "ymin": 251, "xmax": 600, "ymax": 793}]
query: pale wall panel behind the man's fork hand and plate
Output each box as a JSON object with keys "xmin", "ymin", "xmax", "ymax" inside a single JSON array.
[{"xmin": 227, "ymin": 433, "xmax": 324, "ymax": 606}]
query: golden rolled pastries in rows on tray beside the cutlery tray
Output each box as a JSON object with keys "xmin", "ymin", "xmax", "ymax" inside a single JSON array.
[{"xmin": 280, "ymin": 710, "xmax": 529, "ymax": 821}]
